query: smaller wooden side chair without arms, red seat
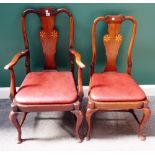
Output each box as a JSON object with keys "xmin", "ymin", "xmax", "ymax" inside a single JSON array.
[{"xmin": 86, "ymin": 15, "xmax": 151, "ymax": 140}]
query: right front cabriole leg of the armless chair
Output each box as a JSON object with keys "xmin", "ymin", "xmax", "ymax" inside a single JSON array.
[{"xmin": 138, "ymin": 107, "xmax": 151, "ymax": 141}]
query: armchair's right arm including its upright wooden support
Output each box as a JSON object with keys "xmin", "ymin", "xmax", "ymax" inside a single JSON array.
[{"xmin": 70, "ymin": 49, "xmax": 85, "ymax": 100}]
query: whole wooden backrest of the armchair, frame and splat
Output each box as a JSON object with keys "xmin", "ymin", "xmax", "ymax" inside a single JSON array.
[{"xmin": 22, "ymin": 8, "xmax": 74, "ymax": 72}]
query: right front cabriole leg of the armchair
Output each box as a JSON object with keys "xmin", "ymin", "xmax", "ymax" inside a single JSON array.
[{"xmin": 71, "ymin": 110, "xmax": 83, "ymax": 143}]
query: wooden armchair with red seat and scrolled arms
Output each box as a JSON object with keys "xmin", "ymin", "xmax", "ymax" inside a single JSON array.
[{"xmin": 5, "ymin": 8, "xmax": 85, "ymax": 143}]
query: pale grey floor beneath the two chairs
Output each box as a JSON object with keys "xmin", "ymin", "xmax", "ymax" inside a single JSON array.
[{"xmin": 0, "ymin": 97, "xmax": 155, "ymax": 151}]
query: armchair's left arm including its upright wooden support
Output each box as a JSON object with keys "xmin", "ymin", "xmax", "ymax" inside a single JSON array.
[{"xmin": 4, "ymin": 50, "xmax": 28, "ymax": 100}]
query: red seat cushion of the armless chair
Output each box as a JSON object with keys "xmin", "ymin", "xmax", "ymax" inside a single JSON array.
[{"xmin": 90, "ymin": 72, "xmax": 146, "ymax": 101}]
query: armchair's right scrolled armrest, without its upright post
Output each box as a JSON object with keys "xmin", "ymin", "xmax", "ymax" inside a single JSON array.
[{"xmin": 70, "ymin": 49, "xmax": 85, "ymax": 69}]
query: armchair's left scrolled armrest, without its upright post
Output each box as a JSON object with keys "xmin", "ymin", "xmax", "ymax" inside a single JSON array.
[{"xmin": 4, "ymin": 49, "xmax": 28, "ymax": 70}]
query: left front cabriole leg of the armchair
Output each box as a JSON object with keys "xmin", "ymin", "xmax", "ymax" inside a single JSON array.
[{"xmin": 9, "ymin": 111, "xmax": 22, "ymax": 144}]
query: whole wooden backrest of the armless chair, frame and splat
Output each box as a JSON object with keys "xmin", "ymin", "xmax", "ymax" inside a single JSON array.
[{"xmin": 91, "ymin": 15, "xmax": 137, "ymax": 76}]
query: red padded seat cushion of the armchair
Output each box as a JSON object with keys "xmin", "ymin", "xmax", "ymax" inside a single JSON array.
[{"xmin": 15, "ymin": 71, "xmax": 77, "ymax": 104}]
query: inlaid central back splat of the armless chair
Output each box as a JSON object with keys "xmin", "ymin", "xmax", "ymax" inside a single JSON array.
[{"xmin": 103, "ymin": 16, "xmax": 123, "ymax": 71}]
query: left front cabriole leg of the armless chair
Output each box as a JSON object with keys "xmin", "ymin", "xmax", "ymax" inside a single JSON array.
[{"xmin": 85, "ymin": 109, "xmax": 98, "ymax": 140}]
